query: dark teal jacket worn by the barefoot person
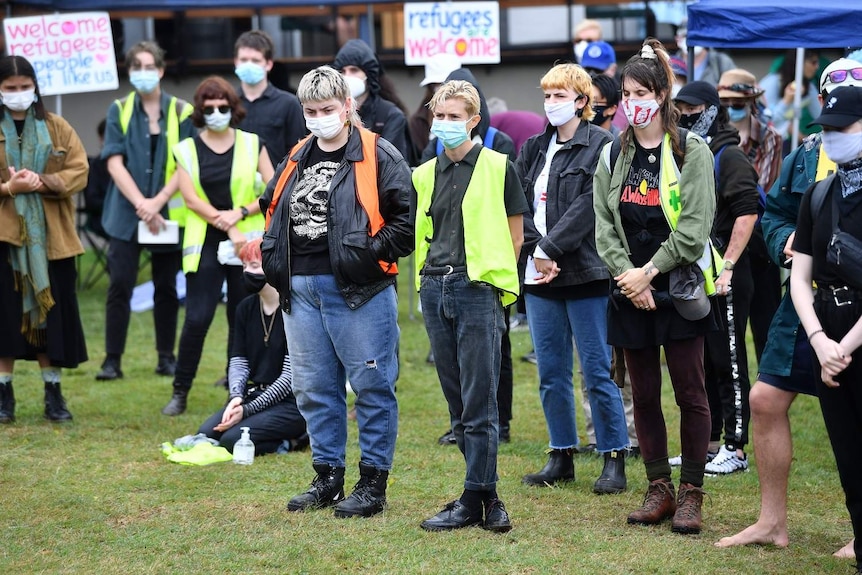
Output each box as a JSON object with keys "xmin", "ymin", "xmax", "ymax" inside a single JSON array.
[{"xmin": 759, "ymin": 134, "xmax": 820, "ymax": 377}]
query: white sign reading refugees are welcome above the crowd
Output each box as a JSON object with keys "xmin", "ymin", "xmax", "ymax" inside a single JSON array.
[{"xmin": 404, "ymin": 2, "xmax": 500, "ymax": 66}]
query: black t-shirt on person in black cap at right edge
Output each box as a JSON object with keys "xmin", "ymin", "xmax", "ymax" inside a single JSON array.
[{"xmin": 793, "ymin": 177, "xmax": 862, "ymax": 286}]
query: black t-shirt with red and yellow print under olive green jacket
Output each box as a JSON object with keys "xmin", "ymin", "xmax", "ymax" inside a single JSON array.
[{"xmin": 620, "ymin": 139, "xmax": 670, "ymax": 290}]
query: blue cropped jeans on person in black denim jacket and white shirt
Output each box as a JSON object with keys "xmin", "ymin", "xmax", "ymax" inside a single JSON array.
[{"xmin": 525, "ymin": 293, "xmax": 629, "ymax": 453}]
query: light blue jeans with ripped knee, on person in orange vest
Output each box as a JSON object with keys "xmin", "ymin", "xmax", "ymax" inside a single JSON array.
[{"xmin": 282, "ymin": 275, "xmax": 399, "ymax": 470}]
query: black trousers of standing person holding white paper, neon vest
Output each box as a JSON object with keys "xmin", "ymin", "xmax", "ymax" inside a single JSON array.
[{"xmin": 105, "ymin": 238, "xmax": 182, "ymax": 356}]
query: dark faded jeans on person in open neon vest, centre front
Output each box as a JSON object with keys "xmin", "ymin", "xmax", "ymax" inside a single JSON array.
[{"xmin": 419, "ymin": 273, "xmax": 505, "ymax": 491}]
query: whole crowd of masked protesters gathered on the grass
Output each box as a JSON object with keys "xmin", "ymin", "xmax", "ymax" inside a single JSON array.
[{"xmin": 0, "ymin": 21, "xmax": 862, "ymax": 568}]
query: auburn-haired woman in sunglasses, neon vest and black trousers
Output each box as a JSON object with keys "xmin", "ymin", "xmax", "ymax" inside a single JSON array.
[{"xmin": 162, "ymin": 76, "xmax": 273, "ymax": 415}]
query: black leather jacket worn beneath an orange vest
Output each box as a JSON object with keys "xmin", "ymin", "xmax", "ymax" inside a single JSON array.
[{"xmin": 260, "ymin": 128, "xmax": 416, "ymax": 313}]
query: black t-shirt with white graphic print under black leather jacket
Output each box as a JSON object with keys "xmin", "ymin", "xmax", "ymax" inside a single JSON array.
[{"xmin": 290, "ymin": 145, "xmax": 344, "ymax": 275}]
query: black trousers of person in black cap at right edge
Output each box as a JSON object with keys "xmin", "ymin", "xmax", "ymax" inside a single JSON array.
[{"xmin": 812, "ymin": 292, "xmax": 862, "ymax": 569}]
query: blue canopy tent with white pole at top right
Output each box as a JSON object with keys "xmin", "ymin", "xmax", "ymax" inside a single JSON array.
[{"xmin": 688, "ymin": 0, "xmax": 862, "ymax": 142}]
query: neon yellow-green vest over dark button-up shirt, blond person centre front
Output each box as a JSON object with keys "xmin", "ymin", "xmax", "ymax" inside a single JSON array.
[{"xmin": 413, "ymin": 148, "xmax": 520, "ymax": 306}]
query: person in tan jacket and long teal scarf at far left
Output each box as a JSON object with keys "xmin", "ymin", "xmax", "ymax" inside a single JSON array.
[{"xmin": 0, "ymin": 56, "xmax": 88, "ymax": 423}]
